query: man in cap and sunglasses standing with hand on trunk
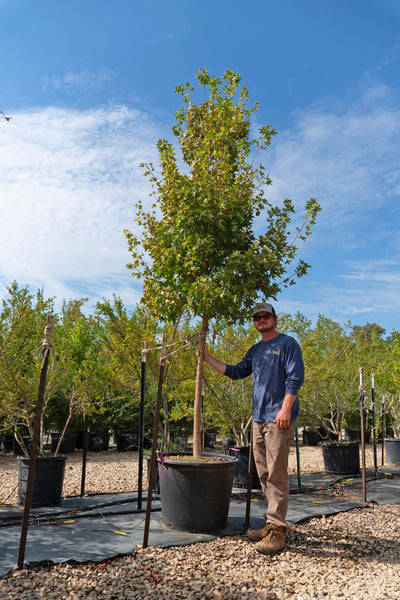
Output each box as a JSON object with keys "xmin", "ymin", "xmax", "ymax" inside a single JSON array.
[{"xmin": 199, "ymin": 302, "xmax": 304, "ymax": 554}]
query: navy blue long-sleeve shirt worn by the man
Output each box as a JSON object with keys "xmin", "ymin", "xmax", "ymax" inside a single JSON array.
[{"xmin": 225, "ymin": 333, "xmax": 304, "ymax": 423}]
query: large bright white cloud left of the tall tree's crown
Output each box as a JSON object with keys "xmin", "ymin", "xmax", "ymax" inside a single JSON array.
[{"xmin": 0, "ymin": 107, "xmax": 157, "ymax": 308}]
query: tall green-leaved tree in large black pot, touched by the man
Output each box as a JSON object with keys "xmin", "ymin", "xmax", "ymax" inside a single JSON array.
[{"xmin": 126, "ymin": 69, "xmax": 319, "ymax": 530}]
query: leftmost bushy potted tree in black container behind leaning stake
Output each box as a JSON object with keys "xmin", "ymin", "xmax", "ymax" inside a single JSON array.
[{"xmin": 0, "ymin": 282, "xmax": 66, "ymax": 506}]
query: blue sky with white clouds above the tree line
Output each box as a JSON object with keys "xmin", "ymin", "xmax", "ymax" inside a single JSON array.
[{"xmin": 0, "ymin": 0, "xmax": 400, "ymax": 333}]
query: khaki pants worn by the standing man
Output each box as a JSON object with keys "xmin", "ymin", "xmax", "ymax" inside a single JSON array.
[{"xmin": 253, "ymin": 421, "xmax": 296, "ymax": 527}]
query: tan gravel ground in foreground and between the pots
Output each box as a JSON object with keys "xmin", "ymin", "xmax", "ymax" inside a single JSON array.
[{"xmin": 0, "ymin": 446, "xmax": 400, "ymax": 600}]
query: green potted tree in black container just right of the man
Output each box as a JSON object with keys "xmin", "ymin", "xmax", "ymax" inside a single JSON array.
[{"xmin": 297, "ymin": 315, "xmax": 385, "ymax": 474}]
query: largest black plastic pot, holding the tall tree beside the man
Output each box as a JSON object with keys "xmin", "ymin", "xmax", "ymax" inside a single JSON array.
[{"xmin": 158, "ymin": 453, "xmax": 237, "ymax": 532}]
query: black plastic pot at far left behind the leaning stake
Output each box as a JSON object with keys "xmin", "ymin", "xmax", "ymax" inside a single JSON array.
[{"xmin": 18, "ymin": 455, "xmax": 67, "ymax": 506}]
